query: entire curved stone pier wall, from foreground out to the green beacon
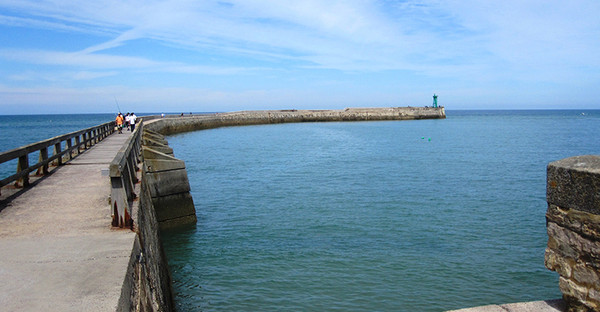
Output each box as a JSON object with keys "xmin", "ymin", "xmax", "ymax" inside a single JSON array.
[{"xmin": 129, "ymin": 108, "xmax": 445, "ymax": 311}]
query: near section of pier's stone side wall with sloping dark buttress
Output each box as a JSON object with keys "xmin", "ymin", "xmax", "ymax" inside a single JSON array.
[{"xmin": 117, "ymin": 129, "xmax": 196, "ymax": 311}]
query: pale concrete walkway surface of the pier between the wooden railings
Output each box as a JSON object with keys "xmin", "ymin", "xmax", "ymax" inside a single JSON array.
[{"xmin": 0, "ymin": 131, "xmax": 136, "ymax": 311}]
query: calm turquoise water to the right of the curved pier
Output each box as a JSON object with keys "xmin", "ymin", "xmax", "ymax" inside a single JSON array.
[{"xmin": 164, "ymin": 110, "xmax": 600, "ymax": 311}]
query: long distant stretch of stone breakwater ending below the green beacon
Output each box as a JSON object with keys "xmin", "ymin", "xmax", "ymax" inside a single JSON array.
[{"xmin": 146, "ymin": 107, "xmax": 446, "ymax": 135}]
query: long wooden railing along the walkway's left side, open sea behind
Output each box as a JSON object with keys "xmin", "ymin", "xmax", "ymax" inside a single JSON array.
[{"xmin": 0, "ymin": 121, "xmax": 115, "ymax": 195}]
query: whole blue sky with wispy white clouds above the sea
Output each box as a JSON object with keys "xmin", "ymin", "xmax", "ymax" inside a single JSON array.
[{"xmin": 0, "ymin": 0, "xmax": 600, "ymax": 114}]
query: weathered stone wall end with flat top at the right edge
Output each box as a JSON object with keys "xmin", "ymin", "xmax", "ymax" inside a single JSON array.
[{"xmin": 545, "ymin": 156, "xmax": 600, "ymax": 311}]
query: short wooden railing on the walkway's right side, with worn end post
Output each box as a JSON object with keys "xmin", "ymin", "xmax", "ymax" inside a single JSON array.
[{"xmin": 109, "ymin": 117, "xmax": 145, "ymax": 228}]
